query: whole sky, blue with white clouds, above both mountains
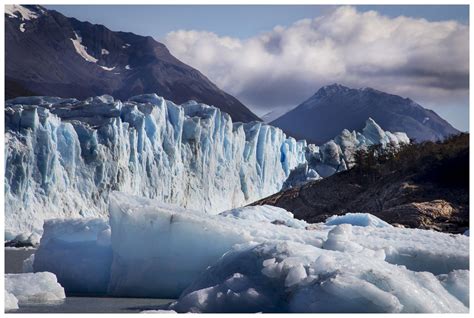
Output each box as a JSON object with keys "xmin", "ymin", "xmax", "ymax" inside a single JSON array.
[{"xmin": 46, "ymin": 5, "xmax": 469, "ymax": 131}]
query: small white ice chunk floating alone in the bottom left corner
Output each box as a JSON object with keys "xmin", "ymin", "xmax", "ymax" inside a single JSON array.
[{"xmin": 5, "ymin": 272, "xmax": 66, "ymax": 307}]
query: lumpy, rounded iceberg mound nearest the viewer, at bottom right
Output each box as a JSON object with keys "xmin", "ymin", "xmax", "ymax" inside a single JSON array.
[{"xmin": 169, "ymin": 241, "xmax": 469, "ymax": 313}]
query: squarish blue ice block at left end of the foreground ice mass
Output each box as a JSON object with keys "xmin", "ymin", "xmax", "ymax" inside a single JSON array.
[{"xmin": 32, "ymin": 218, "xmax": 112, "ymax": 295}]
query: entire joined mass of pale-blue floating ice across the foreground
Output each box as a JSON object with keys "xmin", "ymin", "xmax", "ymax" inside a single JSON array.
[{"xmin": 27, "ymin": 192, "xmax": 469, "ymax": 313}]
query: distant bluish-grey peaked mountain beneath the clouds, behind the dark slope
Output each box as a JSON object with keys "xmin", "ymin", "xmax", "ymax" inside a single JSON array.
[{"xmin": 270, "ymin": 84, "xmax": 459, "ymax": 144}]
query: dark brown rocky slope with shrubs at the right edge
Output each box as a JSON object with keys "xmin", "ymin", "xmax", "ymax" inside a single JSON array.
[{"xmin": 254, "ymin": 134, "xmax": 469, "ymax": 233}]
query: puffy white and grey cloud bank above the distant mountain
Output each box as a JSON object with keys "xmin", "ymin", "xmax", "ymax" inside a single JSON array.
[{"xmin": 165, "ymin": 6, "xmax": 469, "ymax": 125}]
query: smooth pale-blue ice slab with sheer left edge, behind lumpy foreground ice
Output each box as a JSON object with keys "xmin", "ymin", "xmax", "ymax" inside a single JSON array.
[{"xmin": 108, "ymin": 192, "xmax": 324, "ymax": 298}]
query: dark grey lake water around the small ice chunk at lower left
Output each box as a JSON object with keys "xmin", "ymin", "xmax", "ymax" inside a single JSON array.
[{"xmin": 5, "ymin": 248, "xmax": 173, "ymax": 313}]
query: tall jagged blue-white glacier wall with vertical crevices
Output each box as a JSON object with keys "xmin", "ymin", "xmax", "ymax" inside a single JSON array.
[{"xmin": 5, "ymin": 94, "xmax": 406, "ymax": 239}]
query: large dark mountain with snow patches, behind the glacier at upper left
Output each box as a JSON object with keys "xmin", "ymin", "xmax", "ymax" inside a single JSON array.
[{"xmin": 5, "ymin": 5, "xmax": 259, "ymax": 122}]
